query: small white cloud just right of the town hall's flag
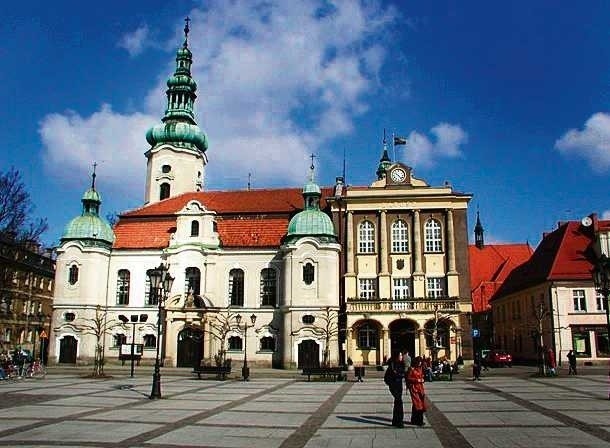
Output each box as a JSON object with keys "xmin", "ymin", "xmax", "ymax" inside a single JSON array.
[{"xmin": 403, "ymin": 123, "xmax": 468, "ymax": 168}]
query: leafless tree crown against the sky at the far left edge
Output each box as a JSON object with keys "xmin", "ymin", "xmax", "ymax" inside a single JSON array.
[{"xmin": 0, "ymin": 168, "xmax": 49, "ymax": 242}]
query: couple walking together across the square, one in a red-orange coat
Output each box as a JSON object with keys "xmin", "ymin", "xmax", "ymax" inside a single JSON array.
[{"xmin": 384, "ymin": 352, "xmax": 426, "ymax": 428}]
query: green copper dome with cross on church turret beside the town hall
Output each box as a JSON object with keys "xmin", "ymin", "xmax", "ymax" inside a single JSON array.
[{"xmin": 286, "ymin": 164, "xmax": 337, "ymax": 243}]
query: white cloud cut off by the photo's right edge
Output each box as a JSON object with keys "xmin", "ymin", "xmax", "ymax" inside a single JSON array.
[{"xmin": 555, "ymin": 112, "xmax": 610, "ymax": 173}]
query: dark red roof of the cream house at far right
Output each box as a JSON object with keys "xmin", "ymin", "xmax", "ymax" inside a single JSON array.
[{"xmin": 492, "ymin": 220, "xmax": 610, "ymax": 300}]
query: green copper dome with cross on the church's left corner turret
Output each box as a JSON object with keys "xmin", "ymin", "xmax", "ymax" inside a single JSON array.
[{"xmin": 61, "ymin": 172, "xmax": 114, "ymax": 247}]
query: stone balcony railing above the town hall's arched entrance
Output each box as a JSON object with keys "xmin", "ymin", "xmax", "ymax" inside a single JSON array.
[{"xmin": 347, "ymin": 297, "xmax": 460, "ymax": 313}]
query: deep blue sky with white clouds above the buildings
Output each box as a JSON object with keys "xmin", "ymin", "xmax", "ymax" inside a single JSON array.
[{"xmin": 0, "ymin": 0, "xmax": 610, "ymax": 245}]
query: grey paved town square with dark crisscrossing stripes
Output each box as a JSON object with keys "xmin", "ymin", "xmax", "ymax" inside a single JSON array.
[{"xmin": 0, "ymin": 374, "xmax": 610, "ymax": 448}]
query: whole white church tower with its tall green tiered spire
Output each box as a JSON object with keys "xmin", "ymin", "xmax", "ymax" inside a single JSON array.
[{"xmin": 145, "ymin": 17, "xmax": 208, "ymax": 204}]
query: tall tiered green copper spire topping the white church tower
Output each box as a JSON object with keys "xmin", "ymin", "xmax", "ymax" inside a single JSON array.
[{"xmin": 146, "ymin": 17, "xmax": 208, "ymax": 152}]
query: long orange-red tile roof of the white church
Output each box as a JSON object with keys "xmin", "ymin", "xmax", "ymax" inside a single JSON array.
[{"xmin": 113, "ymin": 188, "xmax": 332, "ymax": 249}]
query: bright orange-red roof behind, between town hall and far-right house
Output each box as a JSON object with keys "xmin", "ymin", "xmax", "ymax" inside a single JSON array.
[{"xmin": 468, "ymin": 244, "xmax": 533, "ymax": 313}]
